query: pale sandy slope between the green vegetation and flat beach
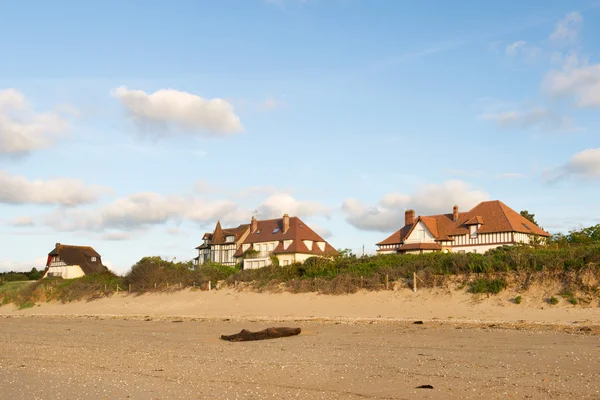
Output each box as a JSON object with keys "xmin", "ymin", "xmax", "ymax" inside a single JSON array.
[{"xmin": 0, "ymin": 289, "xmax": 600, "ymax": 324}]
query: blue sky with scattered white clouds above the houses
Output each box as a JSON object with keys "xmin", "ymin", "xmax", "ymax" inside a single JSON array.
[{"xmin": 0, "ymin": 0, "xmax": 600, "ymax": 273}]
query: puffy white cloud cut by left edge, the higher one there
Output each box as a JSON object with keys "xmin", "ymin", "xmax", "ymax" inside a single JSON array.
[{"xmin": 0, "ymin": 89, "xmax": 69, "ymax": 156}]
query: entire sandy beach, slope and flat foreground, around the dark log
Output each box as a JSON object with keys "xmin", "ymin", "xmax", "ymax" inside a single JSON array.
[{"xmin": 0, "ymin": 290, "xmax": 600, "ymax": 400}]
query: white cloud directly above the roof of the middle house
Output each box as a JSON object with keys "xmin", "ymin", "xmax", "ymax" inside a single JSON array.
[{"xmin": 258, "ymin": 193, "xmax": 331, "ymax": 219}]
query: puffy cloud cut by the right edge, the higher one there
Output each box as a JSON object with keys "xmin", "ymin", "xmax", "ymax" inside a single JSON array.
[{"xmin": 542, "ymin": 55, "xmax": 600, "ymax": 107}]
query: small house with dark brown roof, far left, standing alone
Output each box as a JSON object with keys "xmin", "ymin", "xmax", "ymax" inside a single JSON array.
[{"xmin": 42, "ymin": 243, "xmax": 107, "ymax": 279}]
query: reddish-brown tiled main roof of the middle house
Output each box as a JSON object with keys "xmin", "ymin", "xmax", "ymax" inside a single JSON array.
[{"xmin": 235, "ymin": 217, "xmax": 338, "ymax": 257}]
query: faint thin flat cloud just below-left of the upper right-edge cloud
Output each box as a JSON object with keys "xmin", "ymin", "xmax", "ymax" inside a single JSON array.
[{"xmin": 479, "ymin": 107, "xmax": 576, "ymax": 131}]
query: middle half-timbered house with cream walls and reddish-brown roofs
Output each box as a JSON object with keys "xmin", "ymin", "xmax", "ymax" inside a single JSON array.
[{"xmin": 195, "ymin": 214, "xmax": 337, "ymax": 269}]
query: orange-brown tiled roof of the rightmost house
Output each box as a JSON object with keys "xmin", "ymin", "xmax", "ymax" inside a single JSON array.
[{"xmin": 377, "ymin": 200, "xmax": 550, "ymax": 245}]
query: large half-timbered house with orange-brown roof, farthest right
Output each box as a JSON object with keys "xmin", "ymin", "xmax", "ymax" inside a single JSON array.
[{"xmin": 377, "ymin": 200, "xmax": 550, "ymax": 254}]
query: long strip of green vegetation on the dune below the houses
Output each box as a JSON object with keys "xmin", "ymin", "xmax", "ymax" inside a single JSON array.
[{"xmin": 0, "ymin": 223, "xmax": 600, "ymax": 305}]
